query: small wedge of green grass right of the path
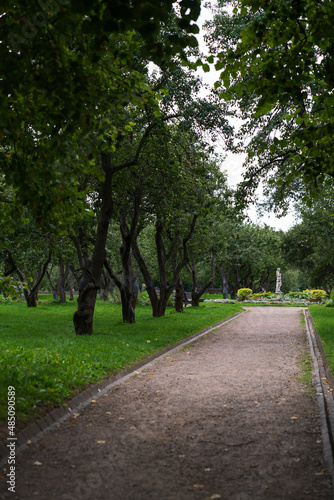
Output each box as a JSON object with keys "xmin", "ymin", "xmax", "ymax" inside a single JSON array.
[{"xmin": 308, "ymin": 306, "xmax": 334, "ymax": 374}]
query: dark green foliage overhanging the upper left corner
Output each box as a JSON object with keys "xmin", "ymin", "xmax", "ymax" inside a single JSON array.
[{"xmin": 0, "ymin": 0, "xmax": 200, "ymax": 229}]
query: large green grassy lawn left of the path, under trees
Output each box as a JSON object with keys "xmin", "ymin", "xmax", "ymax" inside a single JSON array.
[{"xmin": 0, "ymin": 295, "xmax": 242, "ymax": 426}]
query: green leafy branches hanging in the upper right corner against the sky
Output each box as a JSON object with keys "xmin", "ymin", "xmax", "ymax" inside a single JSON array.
[{"xmin": 205, "ymin": 0, "xmax": 334, "ymax": 210}]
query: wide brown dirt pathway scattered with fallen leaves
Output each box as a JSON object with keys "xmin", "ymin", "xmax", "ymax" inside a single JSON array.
[{"xmin": 0, "ymin": 307, "xmax": 331, "ymax": 500}]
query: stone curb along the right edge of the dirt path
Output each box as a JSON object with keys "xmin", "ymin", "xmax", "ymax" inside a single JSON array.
[{"xmin": 304, "ymin": 309, "xmax": 334, "ymax": 500}]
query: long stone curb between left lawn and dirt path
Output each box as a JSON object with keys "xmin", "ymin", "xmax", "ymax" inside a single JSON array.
[{"xmin": 0, "ymin": 310, "xmax": 246, "ymax": 466}]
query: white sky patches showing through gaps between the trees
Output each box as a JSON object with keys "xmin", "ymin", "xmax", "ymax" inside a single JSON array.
[{"xmin": 196, "ymin": 6, "xmax": 295, "ymax": 231}]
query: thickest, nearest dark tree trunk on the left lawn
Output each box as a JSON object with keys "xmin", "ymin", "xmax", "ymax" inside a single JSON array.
[{"xmin": 73, "ymin": 153, "xmax": 112, "ymax": 335}]
